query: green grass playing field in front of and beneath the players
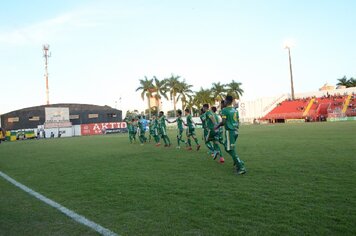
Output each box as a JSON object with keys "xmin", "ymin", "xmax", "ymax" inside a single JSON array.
[{"xmin": 0, "ymin": 122, "xmax": 356, "ymax": 235}]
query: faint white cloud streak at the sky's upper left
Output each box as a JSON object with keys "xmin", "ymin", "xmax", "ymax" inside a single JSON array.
[{"xmin": 0, "ymin": 11, "xmax": 99, "ymax": 45}]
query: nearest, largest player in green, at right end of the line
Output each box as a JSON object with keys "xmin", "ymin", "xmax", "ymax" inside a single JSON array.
[{"xmin": 215, "ymin": 96, "xmax": 246, "ymax": 175}]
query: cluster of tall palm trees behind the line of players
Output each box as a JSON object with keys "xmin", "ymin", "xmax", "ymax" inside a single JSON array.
[{"xmin": 136, "ymin": 74, "xmax": 244, "ymax": 117}]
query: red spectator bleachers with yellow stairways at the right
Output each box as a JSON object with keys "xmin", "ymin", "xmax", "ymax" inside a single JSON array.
[{"xmin": 263, "ymin": 95, "xmax": 356, "ymax": 122}]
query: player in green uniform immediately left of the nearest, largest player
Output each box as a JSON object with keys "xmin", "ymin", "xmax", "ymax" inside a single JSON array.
[{"xmin": 203, "ymin": 104, "xmax": 225, "ymax": 163}]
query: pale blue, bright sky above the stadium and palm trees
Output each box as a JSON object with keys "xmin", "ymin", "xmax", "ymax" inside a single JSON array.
[{"xmin": 0, "ymin": 0, "xmax": 356, "ymax": 114}]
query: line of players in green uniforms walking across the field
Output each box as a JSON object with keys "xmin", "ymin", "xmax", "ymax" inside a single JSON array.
[{"xmin": 125, "ymin": 96, "xmax": 246, "ymax": 174}]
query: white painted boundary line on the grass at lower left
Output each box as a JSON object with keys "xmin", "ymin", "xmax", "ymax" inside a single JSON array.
[{"xmin": 0, "ymin": 171, "xmax": 117, "ymax": 236}]
